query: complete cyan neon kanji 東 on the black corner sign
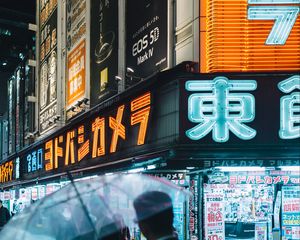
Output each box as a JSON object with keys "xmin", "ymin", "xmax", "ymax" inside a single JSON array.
[{"xmin": 185, "ymin": 77, "xmax": 256, "ymax": 142}]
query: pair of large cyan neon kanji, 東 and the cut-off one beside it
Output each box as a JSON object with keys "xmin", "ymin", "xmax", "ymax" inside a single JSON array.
[{"xmin": 185, "ymin": 75, "xmax": 300, "ymax": 142}]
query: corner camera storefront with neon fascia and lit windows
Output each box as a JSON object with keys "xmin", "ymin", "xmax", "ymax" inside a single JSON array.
[{"xmin": 0, "ymin": 67, "xmax": 300, "ymax": 240}]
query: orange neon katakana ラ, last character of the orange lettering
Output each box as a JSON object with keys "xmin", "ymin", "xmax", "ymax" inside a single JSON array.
[{"xmin": 131, "ymin": 92, "xmax": 151, "ymax": 145}]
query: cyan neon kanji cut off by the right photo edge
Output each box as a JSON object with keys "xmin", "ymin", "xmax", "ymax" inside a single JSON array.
[{"xmin": 278, "ymin": 75, "xmax": 300, "ymax": 139}]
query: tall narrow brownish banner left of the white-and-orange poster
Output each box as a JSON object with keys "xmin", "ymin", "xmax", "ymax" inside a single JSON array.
[{"xmin": 39, "ymin": 0, "xmax": 57, "ymax": 134}]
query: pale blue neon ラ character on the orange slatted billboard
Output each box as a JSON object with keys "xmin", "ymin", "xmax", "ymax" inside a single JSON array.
[{"xmin": 248, "ymin": 0, "xmax": 300, "ymax": 45}]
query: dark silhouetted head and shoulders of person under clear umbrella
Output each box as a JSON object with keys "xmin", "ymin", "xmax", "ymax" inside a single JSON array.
[{"xmin": 133, "ymin": 191, "xmax": 178, "ymax": 240}]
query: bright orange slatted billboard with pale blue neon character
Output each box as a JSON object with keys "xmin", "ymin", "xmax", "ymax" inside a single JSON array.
[{"xmin": 199, "ymin": 0, "xmax": 300, "ymax": 73}]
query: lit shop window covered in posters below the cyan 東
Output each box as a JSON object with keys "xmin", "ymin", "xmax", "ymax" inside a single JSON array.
[{"xmin": 204, "ymin": 184, "xmax": 274, "ymax": 239}]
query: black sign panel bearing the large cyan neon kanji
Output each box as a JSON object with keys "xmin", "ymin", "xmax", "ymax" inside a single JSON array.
[{"xmin": 181, "ymin": 74, "xmax": 300, "ymax": 146}]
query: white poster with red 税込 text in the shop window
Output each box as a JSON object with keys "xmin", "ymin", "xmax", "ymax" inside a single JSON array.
[{"xmin": 204, "ymin": 189, "xmax": 225, "ymax": 240}]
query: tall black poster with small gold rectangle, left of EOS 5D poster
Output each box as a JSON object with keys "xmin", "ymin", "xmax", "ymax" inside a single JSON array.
[{"xmin": 90, "ymin": 0, "xmax": 118, "ymax": 106}]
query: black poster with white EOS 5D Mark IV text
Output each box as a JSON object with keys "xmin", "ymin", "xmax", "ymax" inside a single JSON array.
[{"xmin": 126, "ymin": 0, "xmax": 168, "ymax": 80}]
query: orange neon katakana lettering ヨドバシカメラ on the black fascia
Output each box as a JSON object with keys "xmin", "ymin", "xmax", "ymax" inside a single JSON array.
[{"xmin": 45, "ymin": 92, "xmax": 151, "ymax": 171}]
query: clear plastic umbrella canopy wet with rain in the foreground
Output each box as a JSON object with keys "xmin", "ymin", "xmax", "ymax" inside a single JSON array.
[{"xmin": 0, "ymin": 174, "xmax": 189, "ymax": 240}]
